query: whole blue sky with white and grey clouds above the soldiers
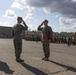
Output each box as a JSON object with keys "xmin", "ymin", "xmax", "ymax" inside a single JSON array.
[{"xmin": 0, "ymin": 0, "xmax": 76, "ymax": 32}]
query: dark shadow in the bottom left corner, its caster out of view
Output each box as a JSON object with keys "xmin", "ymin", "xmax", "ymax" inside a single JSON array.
[{"xmin": 0, "ymin": 61, "xmax": 14, "ymax": 74}]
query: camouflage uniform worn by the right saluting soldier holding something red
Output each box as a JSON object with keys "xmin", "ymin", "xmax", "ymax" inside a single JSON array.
[{"xmin": 38, "ymin": 25, "xmax": 52, "ymax": 57}]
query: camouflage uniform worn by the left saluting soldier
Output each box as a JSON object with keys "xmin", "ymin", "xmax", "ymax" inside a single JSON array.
[{"xmin": 12, "ymin": 24, "xmax": 27, "ymax": 58}]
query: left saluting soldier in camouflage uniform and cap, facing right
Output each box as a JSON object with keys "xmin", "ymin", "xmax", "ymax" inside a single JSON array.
[{"xmin": 12, "ymin": 17, "xmax": 28, "ymax": 62}]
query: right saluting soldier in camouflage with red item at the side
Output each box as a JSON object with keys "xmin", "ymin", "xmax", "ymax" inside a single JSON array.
[{"xmin": 38, "ymin": 20, "xmax": 53, "ymax": 61}]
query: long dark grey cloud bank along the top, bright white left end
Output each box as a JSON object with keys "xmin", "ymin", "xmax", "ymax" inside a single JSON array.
[{"xmin": 12, "ymin": 0, "xmax": 76, "ymax": 18}]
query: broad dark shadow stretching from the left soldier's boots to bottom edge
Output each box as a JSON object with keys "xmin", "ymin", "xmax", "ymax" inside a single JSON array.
[{"xmin": 20, "ymin": 63, "xmax": 48, "ymax": 75}]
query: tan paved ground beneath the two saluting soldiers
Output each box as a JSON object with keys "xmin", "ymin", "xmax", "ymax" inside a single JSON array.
[{"xmin": 0, "ymin": 39, "xmax": 76, "ymax": 75}]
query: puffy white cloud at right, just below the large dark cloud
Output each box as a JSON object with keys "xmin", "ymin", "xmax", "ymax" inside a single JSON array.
[{"xmin": 59, "ymin": 17, "xmax": 76, "ymax": 31}]
